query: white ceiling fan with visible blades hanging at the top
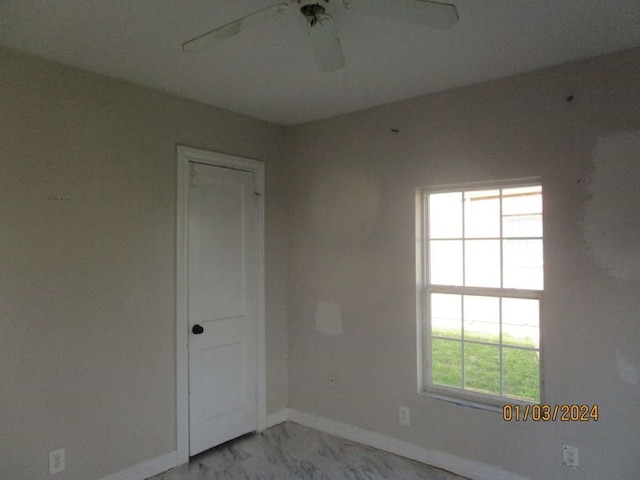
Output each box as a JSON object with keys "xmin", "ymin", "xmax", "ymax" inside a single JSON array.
[{"xmin": 182, "ymin": 0, "xmax": 458, "ymax": 72}]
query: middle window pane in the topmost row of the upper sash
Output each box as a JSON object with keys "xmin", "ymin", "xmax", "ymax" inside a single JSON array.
[{"xmin": 464, "ymin": 190, "xmax": 500, "ymax": 238}]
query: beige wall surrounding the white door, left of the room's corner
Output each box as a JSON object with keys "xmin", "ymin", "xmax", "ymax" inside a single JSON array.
[{"xmin": 0, "ymin": 50, "xmax": 287, "ymax": 480}]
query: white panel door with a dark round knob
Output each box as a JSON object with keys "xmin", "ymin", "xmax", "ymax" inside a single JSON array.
[{"xmin": 188, "ymin": 163, "xmax": 259, "ymax": 455}]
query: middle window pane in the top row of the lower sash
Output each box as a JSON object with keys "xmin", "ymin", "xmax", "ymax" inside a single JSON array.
[{"xmin": 464, "ymin": 295, "xmax": 500, "ymax": 343}]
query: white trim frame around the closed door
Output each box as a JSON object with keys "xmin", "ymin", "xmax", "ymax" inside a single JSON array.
[{"xmin": 176, "ymin": 145, "xmax": 267, "ymax": 464}]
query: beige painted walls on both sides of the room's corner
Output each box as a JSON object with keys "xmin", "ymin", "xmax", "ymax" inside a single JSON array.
[{"xmin": 0, "ymin": 41, "xmax": 640, "ymax": 480}]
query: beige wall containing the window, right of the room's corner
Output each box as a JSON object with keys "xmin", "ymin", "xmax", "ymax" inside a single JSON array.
[{"xmin": 285, "ymin": 50, "xmax": 640, "ymax": 480}]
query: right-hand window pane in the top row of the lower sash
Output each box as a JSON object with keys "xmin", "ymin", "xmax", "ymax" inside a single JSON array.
[{"xmin": 502, "ymin": 298, "xmax": 540, "ymax": 348}]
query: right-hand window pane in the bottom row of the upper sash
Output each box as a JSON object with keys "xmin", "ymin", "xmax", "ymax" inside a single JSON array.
[{"xmin": 503, "ymin": 240, "xmax": 543, "ymax": 290}]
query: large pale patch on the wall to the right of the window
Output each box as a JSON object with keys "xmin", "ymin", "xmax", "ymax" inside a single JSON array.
[{"xmin": 584, "ymin": 131, "xmax": 640, "ymax": 280}]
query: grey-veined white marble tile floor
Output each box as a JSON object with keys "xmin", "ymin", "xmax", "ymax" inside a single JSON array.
[{"xmin": 150, "ymin": 422, "xmax": 464, "ymax": 480}]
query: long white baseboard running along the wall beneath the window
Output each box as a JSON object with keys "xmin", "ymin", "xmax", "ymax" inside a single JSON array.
[{"xmin": 278, "ymin": 409, "xmax": 527, "ymax": 480}]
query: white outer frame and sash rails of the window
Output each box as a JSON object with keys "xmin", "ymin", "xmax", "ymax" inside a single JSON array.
[{"xmin": 416, "ymin": 177, "xmax": 545, "ymax": 411}]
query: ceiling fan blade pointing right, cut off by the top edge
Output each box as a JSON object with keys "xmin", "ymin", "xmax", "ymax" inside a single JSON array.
[{"xmin": 349, "ymin": 0, "xmax": 459, "ymax": 28}]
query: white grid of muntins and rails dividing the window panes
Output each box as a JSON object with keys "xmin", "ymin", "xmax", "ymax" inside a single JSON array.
[{"xmin": 422, "ymin": 182, "xmax": 544, "ymax": 405}]
